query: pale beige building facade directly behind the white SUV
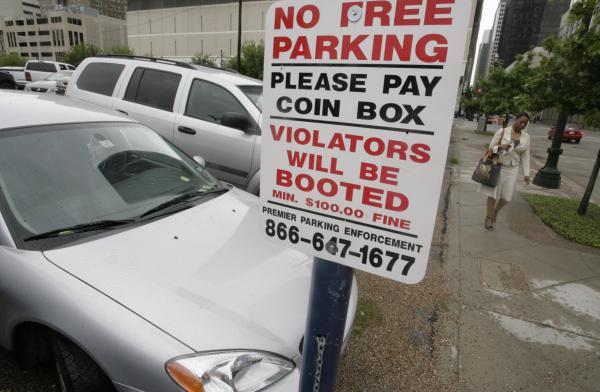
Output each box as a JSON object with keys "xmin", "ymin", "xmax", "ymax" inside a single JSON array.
[{"xmin": 127, "ymin": 0, "xmax": 274, "ymax": 63}]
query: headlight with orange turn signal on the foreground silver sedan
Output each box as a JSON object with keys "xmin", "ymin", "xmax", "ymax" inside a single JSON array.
[{"xmin": 167, "ymin": 350, "xmax": 294, "ymax": 392}]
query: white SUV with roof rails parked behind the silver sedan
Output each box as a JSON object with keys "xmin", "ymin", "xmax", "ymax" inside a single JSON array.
[{"xmin": 66, "ymin": 55, "xmax": 262, "ymax": 194}]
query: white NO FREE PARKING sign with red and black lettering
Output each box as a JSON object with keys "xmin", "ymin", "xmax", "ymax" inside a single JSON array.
[{"xmin": 261, "ymin": 0, "xmax": 471, "ymax": 283}]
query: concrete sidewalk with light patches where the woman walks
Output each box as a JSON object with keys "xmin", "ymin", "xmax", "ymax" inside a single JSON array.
[{"xmin": 438, "ymin": 120, "xmax": 600, "ymax": 392}]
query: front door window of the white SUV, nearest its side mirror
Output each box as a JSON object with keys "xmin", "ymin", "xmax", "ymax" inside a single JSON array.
[{"xmin": 185, "ymin": 79, "xmax": 252, "ymax": 128}]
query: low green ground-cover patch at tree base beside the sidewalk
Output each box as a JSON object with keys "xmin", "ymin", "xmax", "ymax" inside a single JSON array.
[{"xmin": 526, "ymin": 195, "xmax": 600, "ymax": 248}]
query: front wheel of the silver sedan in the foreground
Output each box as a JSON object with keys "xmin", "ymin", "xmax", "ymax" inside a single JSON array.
[{"xmin": 52, "ymin": 335, "xmax": 115, "ymax": 392}]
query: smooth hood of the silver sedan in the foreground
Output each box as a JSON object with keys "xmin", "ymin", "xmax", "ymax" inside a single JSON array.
[{"xmin": 44, "ymin": 190, "xmax": 311, "ymax": 358}]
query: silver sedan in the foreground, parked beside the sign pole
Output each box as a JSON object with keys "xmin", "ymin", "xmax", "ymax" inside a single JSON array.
[{"xmin": 0, "ymin": 92, "xmax": 357, "ymax": 392}]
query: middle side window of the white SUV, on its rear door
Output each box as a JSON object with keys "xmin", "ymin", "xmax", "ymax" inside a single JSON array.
[{"xmin": 123, "ymin": 68, "xmax": 181, "ymax": 112}]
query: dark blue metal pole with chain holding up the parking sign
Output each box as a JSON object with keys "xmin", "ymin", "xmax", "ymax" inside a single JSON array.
[{"xmin": 299, "ymin": 257, "xmax": 353, "ymax": 392}]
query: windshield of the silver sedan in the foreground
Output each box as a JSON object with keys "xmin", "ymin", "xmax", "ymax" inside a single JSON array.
[{"xmin": 0, "ymin": 123, "xmax": 220, "ymax": 245}]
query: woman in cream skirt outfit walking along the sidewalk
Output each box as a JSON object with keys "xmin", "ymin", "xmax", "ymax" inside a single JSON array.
[{"xmin": 479, "ymin": 113, "xmax": 531, "ymax": 230}]
